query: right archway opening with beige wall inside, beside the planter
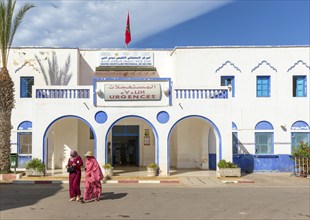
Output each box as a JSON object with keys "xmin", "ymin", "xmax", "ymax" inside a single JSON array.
[{"xmin": 168, "ymin": 115, "xmax": 222, "ymax": 172}]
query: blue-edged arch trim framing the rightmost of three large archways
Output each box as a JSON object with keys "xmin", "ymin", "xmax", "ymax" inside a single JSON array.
[{"xmin": 167, "ymin": 115, "xmax": 222, "ymax": 174}]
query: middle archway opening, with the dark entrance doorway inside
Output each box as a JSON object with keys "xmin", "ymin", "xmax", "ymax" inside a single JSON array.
[{"xmin": 105, "ymin": 115, "xmax": 159, "ymax": 167}]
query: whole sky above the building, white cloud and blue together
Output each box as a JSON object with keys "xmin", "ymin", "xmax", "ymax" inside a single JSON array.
[{"xmin": 13, "ymin": 0, "xmax": 310, "ymax": 49}]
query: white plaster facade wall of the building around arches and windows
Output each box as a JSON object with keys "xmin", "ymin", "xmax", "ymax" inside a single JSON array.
[{"xmin": 9, "ymin": 47, "xmax": 310, "ymax": 173}]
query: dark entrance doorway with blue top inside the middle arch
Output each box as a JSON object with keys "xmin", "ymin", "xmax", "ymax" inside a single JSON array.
[{"xmin": 112, "ymin": 125, "xmax": 139, "ymax": 166}]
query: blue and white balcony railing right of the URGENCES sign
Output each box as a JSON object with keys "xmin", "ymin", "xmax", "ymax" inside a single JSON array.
[{"xmin": 175, "ymin": 89, "xmax": 228, "ymax": 99}]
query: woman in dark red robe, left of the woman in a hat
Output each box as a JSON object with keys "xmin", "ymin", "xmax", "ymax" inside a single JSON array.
[{"xmin": 67, "ymin": 150, "xmax": 83, "ymax": 201}]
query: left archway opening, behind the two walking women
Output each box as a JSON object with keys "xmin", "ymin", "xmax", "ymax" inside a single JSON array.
[{"xmin": 43, "ymin": 115, "xmax": 97, "ymax": 170}]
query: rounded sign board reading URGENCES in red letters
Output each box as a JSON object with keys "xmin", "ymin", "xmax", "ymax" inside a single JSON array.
[{"xmin": 104, "ymin": 84, "xmax": 162, "ymax": 101}]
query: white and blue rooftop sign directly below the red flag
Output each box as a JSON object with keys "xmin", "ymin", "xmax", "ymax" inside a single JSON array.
[{"xmin": 99, "ymin": 52, "xmax": 154, "ymax": 66}]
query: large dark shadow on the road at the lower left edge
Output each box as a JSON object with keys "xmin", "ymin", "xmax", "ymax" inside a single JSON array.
[{"xmin": 0, "ymin": 184, "xmax": 63, "ymax": 211}]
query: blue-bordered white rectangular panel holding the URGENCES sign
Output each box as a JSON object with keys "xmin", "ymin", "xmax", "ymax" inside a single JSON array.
[{"xmin": 93, "ymin": 78, "xmax": 172, "ymax": 107}]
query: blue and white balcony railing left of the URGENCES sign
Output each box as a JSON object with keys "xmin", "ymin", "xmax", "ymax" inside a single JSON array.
[{"xmin": 36, "ymin": 89, "xmax": 90, "ymax": 99}]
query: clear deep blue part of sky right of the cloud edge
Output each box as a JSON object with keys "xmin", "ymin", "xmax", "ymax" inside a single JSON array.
[{"xmin": 135, "ymin": 0, "xmax": 310, "ymax": 48}]
